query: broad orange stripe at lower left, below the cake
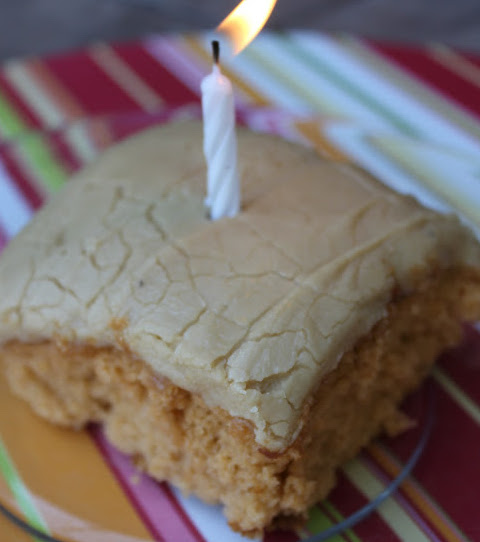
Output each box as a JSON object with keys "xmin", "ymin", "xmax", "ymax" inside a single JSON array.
[{"xmin": 0, "ymin": 374, "xmax": 151, "ymax": 542}]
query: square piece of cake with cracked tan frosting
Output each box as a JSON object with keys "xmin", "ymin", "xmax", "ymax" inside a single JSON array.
[{"xmin": 0, "ymin": 122, "xmax": 480, "ymax": 536}]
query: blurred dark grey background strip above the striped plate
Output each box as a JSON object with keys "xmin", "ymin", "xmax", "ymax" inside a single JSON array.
[{"xmin": 0, "ymin": 0, "xmax": 480, "ymax": 60}]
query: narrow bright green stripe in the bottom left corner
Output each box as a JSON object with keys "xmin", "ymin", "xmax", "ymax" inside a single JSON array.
[{"xmin": 0, "ymin": 437, "xmax": 50, "ymax": 534}]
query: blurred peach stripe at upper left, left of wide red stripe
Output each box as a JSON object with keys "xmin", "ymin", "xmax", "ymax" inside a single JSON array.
[{"xmin": 24, "ymin": 59, "xmax": 85, "ymax": 120}]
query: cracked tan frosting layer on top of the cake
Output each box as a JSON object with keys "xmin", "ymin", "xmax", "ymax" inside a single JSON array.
[{"xmin": 0, "ymin": 123, "xmax": 480, "ymax": 451}]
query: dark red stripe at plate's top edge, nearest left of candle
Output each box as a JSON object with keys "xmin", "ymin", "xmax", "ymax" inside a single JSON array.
[{"xmin": 112, "ymin": 44, "xmax": 198, "ymax": 106}]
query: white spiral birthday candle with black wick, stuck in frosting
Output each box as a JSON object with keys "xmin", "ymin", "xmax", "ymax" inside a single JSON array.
[{"xmin": 201, "ymin": 42, "xmax": 240, "ymax": 220}]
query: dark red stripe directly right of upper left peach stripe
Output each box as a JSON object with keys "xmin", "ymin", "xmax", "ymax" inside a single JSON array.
[{"xmin": 44, "ymin": 51, "xmax": 139, "ymax": 115}]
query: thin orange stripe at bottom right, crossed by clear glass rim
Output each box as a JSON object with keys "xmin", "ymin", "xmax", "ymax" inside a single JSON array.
[{"xmin": 368, "ymin": 444, "xmax": 466, "ymax": 542}]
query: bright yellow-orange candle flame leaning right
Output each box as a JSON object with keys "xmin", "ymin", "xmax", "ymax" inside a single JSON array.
[{"xmin": 217, "ymin": 0, "xmax": 277, "ymax": 54}]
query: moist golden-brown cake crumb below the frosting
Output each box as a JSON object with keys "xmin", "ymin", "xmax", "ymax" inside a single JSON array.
[{"xmin": 0, "ymin": 270, "xmax": 480, "ymax": 535}]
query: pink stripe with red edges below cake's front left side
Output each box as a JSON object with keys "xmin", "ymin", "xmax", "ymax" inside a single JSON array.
[{"xmin": 90, "ymin": 426, "xmax": 206, "ymax": 542}]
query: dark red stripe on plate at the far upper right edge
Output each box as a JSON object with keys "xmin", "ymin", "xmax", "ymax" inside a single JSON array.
[{"xmin": 370, "ymin": 42, "xmax": 480, "ymax": 116}]
